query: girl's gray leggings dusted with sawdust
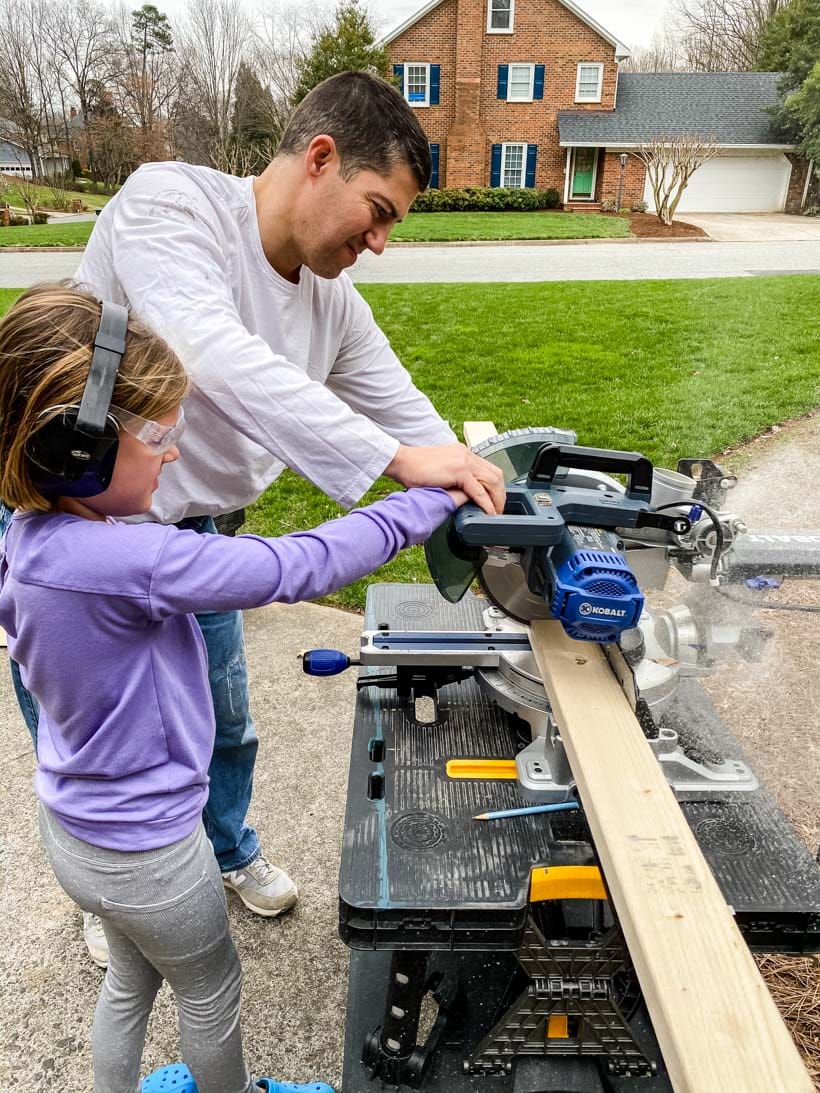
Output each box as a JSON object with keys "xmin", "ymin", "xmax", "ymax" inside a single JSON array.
[{"xmin": 39, "ymin": 804, "xmax": 256, "ymax": 1093}]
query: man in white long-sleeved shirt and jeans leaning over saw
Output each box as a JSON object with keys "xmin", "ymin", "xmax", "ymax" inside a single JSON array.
[{"xmin": 69, "ymin": 72, "xmax": 504, "ymax": 962}]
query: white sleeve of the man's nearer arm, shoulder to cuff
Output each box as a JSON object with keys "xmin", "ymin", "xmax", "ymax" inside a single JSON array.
[{"xmin": 103, "ymin": 179, "xmax": 399, "ymax": 506}]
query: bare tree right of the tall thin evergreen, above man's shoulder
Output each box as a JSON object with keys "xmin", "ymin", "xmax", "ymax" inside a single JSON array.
[{"xmin": 178, "ymin": 0, "xmax": 254, "ymax": 166}]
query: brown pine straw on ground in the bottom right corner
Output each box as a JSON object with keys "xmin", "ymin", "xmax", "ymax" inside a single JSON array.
[{"xmin": 757, "ymin": 954, "xmax": 820, "ymax": 1085}]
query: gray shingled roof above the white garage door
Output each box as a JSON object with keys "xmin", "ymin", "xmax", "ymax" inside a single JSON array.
[{"xmin": 558, "ymin": 72, "xmax": 790, "ymax": 146}]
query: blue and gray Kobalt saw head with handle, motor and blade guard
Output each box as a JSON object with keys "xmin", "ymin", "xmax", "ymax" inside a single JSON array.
[{"xmin": 425, "ymin": 438, "xmax": 691, "ymax": 643}]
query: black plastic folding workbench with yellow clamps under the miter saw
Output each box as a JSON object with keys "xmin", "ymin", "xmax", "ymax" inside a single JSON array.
[{"xmin": 339, "ymin": 585, "xmax": 820, "ymax": 1093}]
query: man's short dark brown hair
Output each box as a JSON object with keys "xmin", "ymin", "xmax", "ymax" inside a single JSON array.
[{"xmin": 277, "ymin": 72, "xmax": 433, "ymax": 190}]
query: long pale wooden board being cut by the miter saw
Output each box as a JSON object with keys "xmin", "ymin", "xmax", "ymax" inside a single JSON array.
[{"xmin": 465, "ymin": 423, "xmax": 813, "ymax": 1093}]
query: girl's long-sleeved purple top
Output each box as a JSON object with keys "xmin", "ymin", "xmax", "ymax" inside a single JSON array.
[{"xmin": 0, "ymin": 490, "xmax": 455, "ymax": 850}]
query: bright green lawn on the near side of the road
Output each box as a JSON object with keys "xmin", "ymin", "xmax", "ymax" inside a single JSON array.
[{"xmin": 0, "ymin": 277, "xmax": 820, "ymax": 609}]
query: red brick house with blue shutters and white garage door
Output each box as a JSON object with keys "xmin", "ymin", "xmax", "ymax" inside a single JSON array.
[{"xmin": 384, "ymin": 0, "xmax": 808, "ymax": 212}]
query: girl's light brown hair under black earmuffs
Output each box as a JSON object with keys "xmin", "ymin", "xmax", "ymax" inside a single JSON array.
[{"xmin": 0, "ymin": 282, "xmax": 188, "ymax": 512}]
